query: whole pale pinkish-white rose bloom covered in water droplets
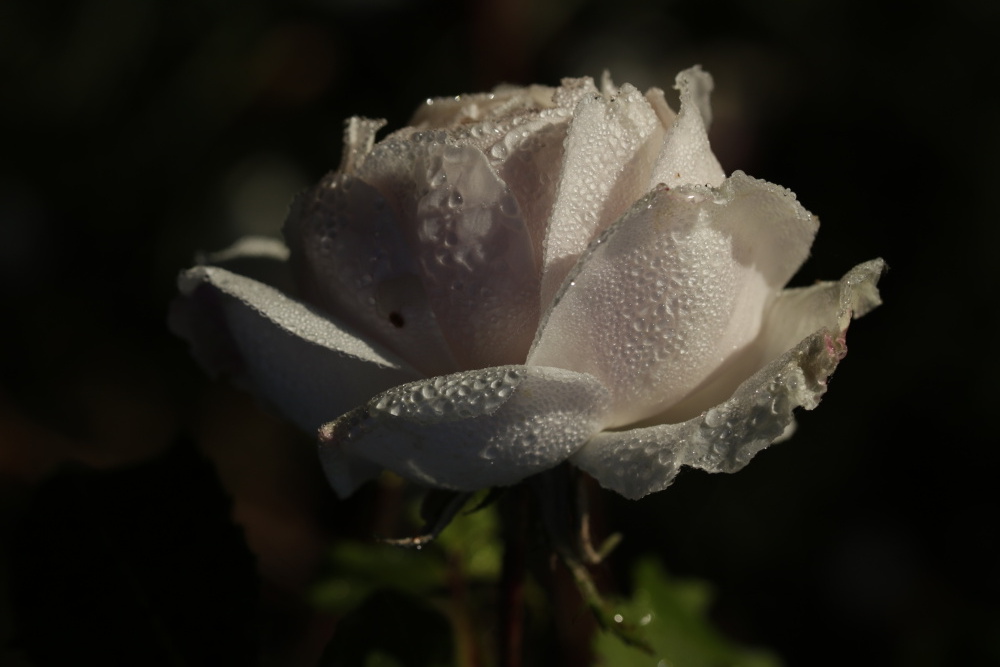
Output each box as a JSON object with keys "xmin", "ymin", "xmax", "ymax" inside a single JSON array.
[{"xmin": 171, "ymin": 67, "xmax": 884, "ymax": 498}]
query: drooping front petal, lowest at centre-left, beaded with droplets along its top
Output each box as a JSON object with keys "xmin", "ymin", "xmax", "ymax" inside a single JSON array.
[{"xmin": 320, "ymin": 366, "xmax": 608, "ymax": 496}]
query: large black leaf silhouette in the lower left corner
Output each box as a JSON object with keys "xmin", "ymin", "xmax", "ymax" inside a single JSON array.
[{"xmin": 11, "ymin": 443, "xmax": 258, "ymax": 666}]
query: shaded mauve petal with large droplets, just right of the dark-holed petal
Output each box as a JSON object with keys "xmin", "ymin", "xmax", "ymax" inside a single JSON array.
[{"xmin": 359, "ymin": 132, "xmax": 540, "ymax": 368}]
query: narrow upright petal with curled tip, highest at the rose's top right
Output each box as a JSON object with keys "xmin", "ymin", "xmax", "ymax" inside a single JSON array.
[{"xmin": 649, "ymin": 67, "xmax": 726, "ymax": 187}]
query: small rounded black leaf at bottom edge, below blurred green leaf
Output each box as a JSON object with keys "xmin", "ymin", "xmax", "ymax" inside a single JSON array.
[{"xmin": 320, "ymin": 590, "xmax": 454, "ymax": 667}]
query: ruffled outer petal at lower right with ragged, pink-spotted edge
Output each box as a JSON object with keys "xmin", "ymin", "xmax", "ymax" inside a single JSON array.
[{"xmin": 571, "ymin": 260, "xmax": 885, "ymax": 498}]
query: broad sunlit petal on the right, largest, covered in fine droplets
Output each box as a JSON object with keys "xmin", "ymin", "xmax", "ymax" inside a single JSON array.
[{"xmin": 528, "ymin": 172, "xmax": 817, "ymax": 427}]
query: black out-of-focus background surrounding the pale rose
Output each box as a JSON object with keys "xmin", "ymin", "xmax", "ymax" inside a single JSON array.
[{"xmin": 0, "ymin": 0, "xmax": 1000, "ymax": 666}]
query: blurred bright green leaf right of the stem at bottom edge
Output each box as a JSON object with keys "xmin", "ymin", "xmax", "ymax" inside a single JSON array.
[{"xmin": 594, "ymin": 559, "xmax": 780, "ymax": 667}]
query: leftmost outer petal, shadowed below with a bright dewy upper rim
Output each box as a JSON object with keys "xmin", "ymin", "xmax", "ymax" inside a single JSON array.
[{"xmin": 170, "ymin": 250, "xmax": 420, "ymax": 431}]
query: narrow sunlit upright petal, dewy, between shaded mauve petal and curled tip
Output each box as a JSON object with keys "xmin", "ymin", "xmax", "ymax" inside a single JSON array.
[{"xmin": 542, "ymin": 84, "xmax": 664, "ymax": 303}]
